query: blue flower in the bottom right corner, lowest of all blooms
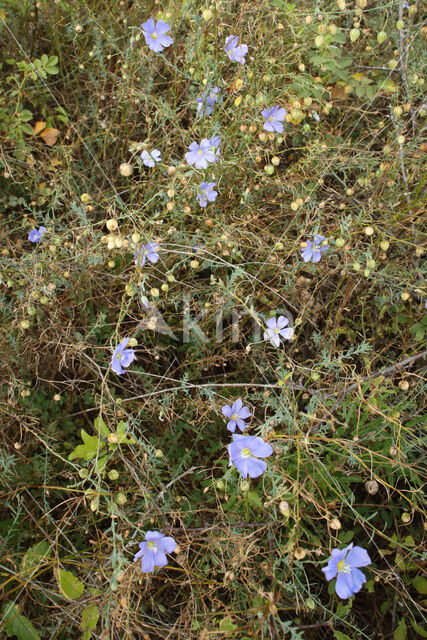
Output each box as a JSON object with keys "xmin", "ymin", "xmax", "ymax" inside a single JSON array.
[{"xmin": 322, "ymin": 543, "xmax": 371, "ymax": 598}]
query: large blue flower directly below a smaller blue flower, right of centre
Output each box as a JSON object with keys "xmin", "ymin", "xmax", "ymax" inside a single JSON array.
[{"xmin": 228, "ymin": 433, "xmax": 273, "ymax": 478}]
